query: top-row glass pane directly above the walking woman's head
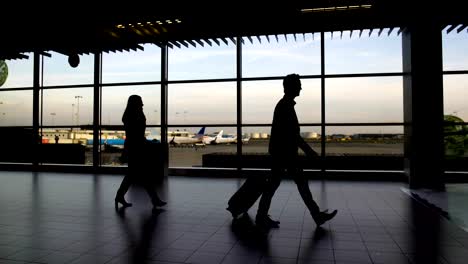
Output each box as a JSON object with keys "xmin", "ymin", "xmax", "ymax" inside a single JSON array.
[{"xmin": 102, "ymin": 44, "xmax": 161, "ymax": 83}]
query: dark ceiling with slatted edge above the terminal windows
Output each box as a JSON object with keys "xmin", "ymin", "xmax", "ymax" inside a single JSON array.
[{"xmin": 0, "ymin": 0, "xmax": 468, "ymax": 59}]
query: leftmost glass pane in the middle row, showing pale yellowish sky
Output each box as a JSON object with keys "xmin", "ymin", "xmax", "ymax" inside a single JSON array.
[{"xmin": 0, "ymin": 90, "xmax": 33, "ymax": 126}]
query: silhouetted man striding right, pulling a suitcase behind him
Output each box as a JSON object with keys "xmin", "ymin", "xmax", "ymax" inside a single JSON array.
[{"xmin": 255, "ymin": 74, "xmax": 337, "ymax": 227}]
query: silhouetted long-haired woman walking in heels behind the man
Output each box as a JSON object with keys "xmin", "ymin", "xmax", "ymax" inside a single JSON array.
[{"xmin": 115, "ymin": 95, "xmax": 166, "ymax": 210}]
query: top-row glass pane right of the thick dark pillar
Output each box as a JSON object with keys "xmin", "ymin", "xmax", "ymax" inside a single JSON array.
[{"xmin": 442, "ymin": 29, "xmax": 468, "ymax": 71}]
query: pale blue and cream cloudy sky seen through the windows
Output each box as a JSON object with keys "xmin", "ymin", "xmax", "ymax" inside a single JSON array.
[{"xmin": 0, "ymin": 29, "xmax": 468, "ymax": 136}]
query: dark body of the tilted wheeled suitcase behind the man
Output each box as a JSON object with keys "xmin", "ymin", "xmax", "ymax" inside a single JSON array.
[{"xmin": 226, "ymin": 177, "xmax": 266, "ymax": 218}]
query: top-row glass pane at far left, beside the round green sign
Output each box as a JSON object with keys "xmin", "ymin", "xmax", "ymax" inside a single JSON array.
[{"xmin": 0, "ymin": 53, "xmax": 34, "ymax": 88}]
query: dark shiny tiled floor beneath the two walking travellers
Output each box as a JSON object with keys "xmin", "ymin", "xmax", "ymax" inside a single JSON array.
[{"xmin": 0, "ymin": 172, "xmax": 468, "ymax": 264}]
